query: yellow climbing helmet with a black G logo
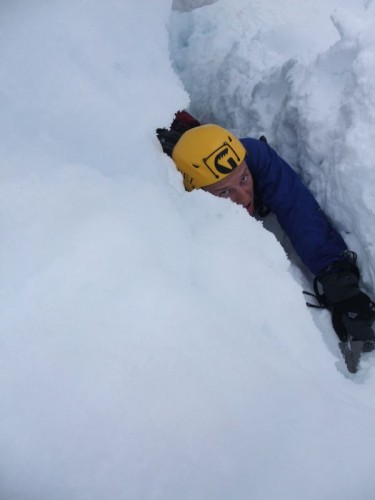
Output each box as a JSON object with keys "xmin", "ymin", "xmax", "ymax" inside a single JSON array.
[{"xmin": 172, "ymin": 124, "xmax": 246, "ymax": 191}]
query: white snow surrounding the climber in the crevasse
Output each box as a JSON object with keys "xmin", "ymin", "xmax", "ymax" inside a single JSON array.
[{"xmin": 0, "ymin": 0, "xmax": 375, "ymax": 500}]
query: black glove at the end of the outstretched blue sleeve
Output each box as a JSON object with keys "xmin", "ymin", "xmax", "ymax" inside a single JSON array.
[{"xmin": 316, "ymin": 254, "xmax": 375, "ymax": 342}]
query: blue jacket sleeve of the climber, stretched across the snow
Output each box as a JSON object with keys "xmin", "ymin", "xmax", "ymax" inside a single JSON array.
[{"xmin": 241, "ymin": 138, "xmax": 347, "ymax": 274}]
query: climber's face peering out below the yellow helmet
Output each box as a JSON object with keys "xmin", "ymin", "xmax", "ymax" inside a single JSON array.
[{"xmin": 203, "ymin": 161, "xmax": 254, "ymax": 215}]
